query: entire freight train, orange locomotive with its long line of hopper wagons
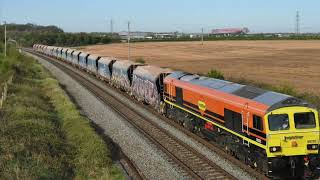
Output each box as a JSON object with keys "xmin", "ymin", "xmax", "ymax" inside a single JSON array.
[{"xmin": 33, "ymin": 44, "xmax": 320, "ymax": 178}]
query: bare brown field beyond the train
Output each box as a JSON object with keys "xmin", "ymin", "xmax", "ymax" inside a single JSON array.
[{"xmin": 81, "ymin": 41, "xmax": 320, "ymax": 94}]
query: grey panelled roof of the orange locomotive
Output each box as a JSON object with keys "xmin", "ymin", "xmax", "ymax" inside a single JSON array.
[{"xmin": 168, "ymin": 71, "xmax": 314, "ymax": 111}]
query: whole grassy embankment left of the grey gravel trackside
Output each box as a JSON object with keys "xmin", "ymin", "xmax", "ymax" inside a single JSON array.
[{"xmin": 0, "ymin": 47, "xmax": 123, "ymax": 179}]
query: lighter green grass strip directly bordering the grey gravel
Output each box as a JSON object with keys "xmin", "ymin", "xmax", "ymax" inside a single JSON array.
[{"xmin": 43, "ymin": 78, "xmax": 122, "ymax": 179}]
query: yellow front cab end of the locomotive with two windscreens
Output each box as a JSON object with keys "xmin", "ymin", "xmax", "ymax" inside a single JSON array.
[{"xmin": 265, "ymin": 106, "xmax": 320, "ymax": 176}]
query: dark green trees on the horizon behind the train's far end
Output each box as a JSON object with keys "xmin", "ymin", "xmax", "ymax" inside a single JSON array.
[{"xmin": 0, "ymin": 24, "xmax": 120, "ymax": 47}]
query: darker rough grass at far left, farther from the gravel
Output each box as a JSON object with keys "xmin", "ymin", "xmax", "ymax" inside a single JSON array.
[{"xmin": 0, "ymin": 77, "xmax": 73, "ymax": 179}]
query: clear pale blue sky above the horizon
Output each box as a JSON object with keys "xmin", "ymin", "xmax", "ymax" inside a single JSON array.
[{"xmin": 0, "ymin": 0, "xmax": 320, "ymax": 33}]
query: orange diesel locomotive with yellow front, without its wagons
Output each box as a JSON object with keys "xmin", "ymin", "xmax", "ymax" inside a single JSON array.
[{"xmin": 164, "ymin": 72, "xmax": 319, "ymax": 177}]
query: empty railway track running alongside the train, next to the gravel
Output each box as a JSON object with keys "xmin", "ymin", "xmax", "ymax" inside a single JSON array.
[{"xmin": 27, "ymin": 50, "xmax": 235, "ymax": 179}]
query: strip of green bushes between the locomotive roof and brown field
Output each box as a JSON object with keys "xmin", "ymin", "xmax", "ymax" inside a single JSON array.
[{"xmin": 207, "ymin": 69, "xmax": 320, "ymax": 110}]
